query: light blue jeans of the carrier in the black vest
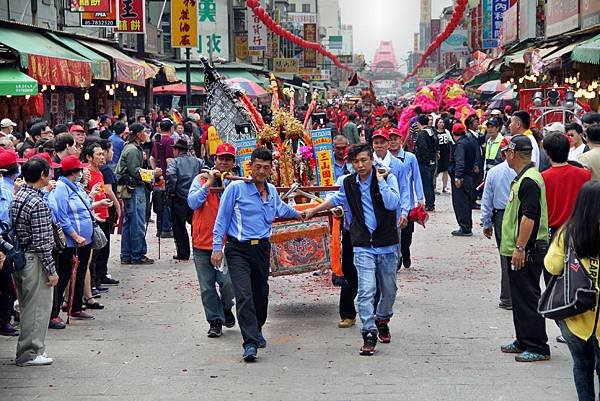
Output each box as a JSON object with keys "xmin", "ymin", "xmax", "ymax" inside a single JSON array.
[{"xmin": 354, "ymin": 252, "xmax": 398, "ymax": 334}]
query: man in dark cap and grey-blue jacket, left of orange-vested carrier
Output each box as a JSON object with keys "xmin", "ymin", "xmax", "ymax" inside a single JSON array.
[{"xmin": 166, "ymin": 139, "xmax": 204, "ymax": 260}]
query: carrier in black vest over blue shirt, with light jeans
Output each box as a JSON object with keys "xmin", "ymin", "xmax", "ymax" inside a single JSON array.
[{"xmin": 304, "ymin": 145, "xmax": 400, "ymax": 355}]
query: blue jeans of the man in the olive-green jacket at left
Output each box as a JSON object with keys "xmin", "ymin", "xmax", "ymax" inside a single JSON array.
[{"xmin": 121, "ymin": 187, "xmax": 148, "ymax": 261}]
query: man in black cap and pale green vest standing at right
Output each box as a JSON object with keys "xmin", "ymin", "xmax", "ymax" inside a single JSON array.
[{"xmin": 500, "ymin": 135, "xmax": 550, "ymax": 362}]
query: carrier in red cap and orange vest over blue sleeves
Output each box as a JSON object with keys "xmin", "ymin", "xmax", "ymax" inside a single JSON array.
[{"xmin": 187, "ymin": 143, "xmax": 235, "ymax": 338}]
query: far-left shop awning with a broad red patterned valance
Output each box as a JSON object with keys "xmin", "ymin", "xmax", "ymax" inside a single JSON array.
[{"xmin": 0, "ymin": 28, "xmax": 92, "ymax": 87}]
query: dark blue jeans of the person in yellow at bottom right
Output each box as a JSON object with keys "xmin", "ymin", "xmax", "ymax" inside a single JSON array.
[{"xmin": 558, "ymin": 320, "xmax": 600, "ymax": 401}]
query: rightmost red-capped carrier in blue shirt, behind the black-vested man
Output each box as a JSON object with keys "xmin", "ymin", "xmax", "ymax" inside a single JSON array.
[{"xmin": 390, "ymin": 128, "xmax": 425, "ymax": 269}]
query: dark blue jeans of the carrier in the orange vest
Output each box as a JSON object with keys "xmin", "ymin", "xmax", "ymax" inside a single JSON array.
[{"xmin": 194, "ymin": 249, "xmax": 235, "ymax": 322}]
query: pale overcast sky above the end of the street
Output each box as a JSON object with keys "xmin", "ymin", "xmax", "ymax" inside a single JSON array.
[{"xmin": 339, "ymin": 0, "xmax": 453, "ymax": 71}]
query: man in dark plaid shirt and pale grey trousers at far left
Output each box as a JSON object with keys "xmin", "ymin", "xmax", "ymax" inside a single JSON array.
[{"xmin": 11, "ymin": 157, "xmax": 58, "ymax": 366}]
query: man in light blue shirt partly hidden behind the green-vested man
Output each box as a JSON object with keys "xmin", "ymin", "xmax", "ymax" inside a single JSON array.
[{"xmin": 481, "ymin": 141, "xmax": 517, "ymax": 310}]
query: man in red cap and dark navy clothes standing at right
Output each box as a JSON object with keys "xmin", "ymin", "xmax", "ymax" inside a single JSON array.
[{"xmin": 448, "ymin": 123, "xmax": 478, "ymax": 237}]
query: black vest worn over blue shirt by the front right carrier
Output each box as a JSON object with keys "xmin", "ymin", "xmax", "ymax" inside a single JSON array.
[{"xmin": 344, "ymin": 169, "xmax": 398, "ymax": 248}]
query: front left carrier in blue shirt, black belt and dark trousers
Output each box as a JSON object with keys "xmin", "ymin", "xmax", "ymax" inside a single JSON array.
[{"xmin": 211, "ymin": 148, "xmax": 301, "ymax": 362}]
